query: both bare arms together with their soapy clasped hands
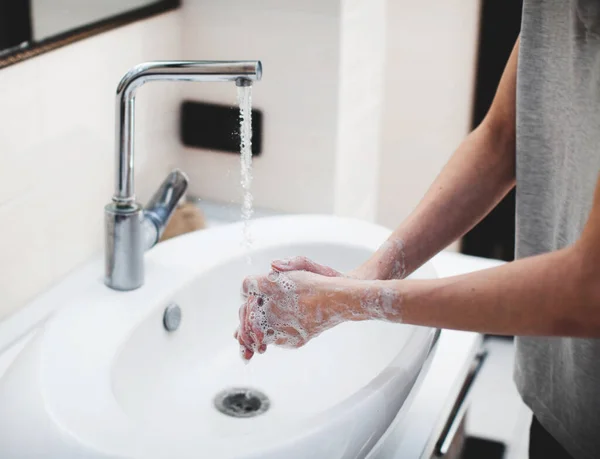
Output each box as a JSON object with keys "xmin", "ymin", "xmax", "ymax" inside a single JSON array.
[{"xmin": 236, "ymin": 36, "xmax": 600, "ymax": 357}]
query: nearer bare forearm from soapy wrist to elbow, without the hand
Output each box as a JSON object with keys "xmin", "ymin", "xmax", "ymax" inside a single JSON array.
[{"xmin": 346, "ymin": 244, "xmax": 600, "ymax": 338}]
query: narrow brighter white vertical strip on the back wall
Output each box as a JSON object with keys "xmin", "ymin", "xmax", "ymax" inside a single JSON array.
[{"xmin": 335, "ymin": 0, "xmax": 386, "ymax": 221}]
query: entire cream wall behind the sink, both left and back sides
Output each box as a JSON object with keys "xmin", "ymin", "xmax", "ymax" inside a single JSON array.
[{"xmin": 0, "ymin": 0, "xmax": 478, "ymax": 319}]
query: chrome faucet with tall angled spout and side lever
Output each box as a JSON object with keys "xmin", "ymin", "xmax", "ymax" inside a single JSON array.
[{"xmin": 104, "ymin": 61, "xmax": 262, "ymax": 290}]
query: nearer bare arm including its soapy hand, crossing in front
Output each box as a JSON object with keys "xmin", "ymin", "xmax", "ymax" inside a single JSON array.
[{"xmin": 236, "ymin": 175, "xmax": 600, "ymax": 358}]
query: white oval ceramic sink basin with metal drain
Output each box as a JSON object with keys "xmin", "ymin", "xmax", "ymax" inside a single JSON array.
[{"xmin": 0, "ymin": 216, "xmax": 435, "ymax": 459}]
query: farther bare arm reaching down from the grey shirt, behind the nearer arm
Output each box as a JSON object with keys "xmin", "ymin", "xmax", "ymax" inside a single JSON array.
[{"xmin": 355, "ymin": 36, "xmax": 519, "ymax": 279}]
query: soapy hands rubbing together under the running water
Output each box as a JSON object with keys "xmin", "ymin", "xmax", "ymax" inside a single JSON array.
[{"xmin": 235, "ymin": 270, "xmax": 366, "ymax": 360}]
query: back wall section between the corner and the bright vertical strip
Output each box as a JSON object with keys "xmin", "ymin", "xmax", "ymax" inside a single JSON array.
[{"xmin": 183, "ymin": 0, "xmax": 341, "ymax": 216}]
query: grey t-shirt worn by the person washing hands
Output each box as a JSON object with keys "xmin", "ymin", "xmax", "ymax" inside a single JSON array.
[{"xmin": 515, "ymin": 0, "xmax": 600, "ymax": 459}]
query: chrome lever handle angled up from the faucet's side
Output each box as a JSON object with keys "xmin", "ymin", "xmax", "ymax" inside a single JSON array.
[{"xmin": 144, "ymin": 169, "xmax": 188, "ymax": 250}]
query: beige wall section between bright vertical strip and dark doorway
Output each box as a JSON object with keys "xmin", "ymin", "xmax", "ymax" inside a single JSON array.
[{"xmin": 377, "ymin": 0, "xmax": 479, "ymax": 227}]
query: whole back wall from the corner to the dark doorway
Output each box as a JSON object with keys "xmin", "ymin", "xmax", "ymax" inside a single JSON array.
[{"xmin": 176, "ymin": 0, "xmax": 479, "ymax": 227}]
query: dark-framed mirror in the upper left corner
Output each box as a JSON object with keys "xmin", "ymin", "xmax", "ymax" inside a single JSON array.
[{"xmin": 0, "ymin": 0, "xmax": 180, "ymax": 68}]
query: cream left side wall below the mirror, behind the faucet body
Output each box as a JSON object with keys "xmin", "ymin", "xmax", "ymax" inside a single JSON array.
[{"xmin": 0, "ymin": 11, "xmax": 181, "ymax": 319}]
